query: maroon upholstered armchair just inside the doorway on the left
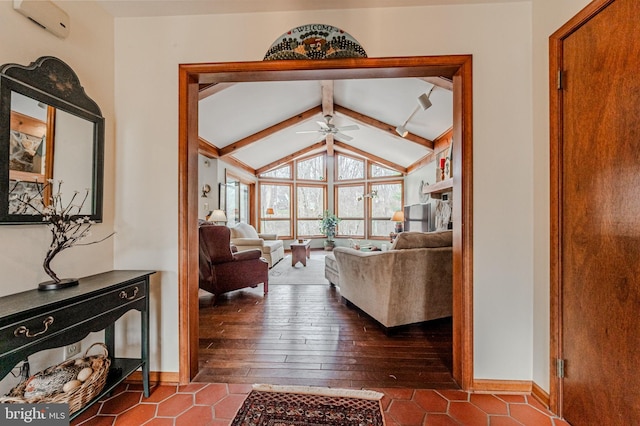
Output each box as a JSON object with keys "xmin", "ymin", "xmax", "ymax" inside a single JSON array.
[{"xmin": 198, "ymin": 224, "xmax": 269, "ymax": 302}]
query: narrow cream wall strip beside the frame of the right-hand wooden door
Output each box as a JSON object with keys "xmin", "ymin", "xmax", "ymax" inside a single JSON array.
[{"xmin": 533, "ymin": 0, "xmax": 590, "ymax": 391}]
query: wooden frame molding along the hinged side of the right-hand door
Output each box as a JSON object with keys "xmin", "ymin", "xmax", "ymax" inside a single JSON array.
[{"xmin": 549, "ymin": 0, "xmax": 614, "ymax": 417}]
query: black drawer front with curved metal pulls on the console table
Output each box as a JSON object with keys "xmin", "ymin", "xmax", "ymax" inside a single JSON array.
[{"xmin": 0, "ymin": 280, "xmax": 147, "ymax": 353}]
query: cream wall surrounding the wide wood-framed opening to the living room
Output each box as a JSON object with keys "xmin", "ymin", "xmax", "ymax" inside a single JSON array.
[{"xmin": 115, "ymin": 2, "xmax": 533, "ymax": 380}]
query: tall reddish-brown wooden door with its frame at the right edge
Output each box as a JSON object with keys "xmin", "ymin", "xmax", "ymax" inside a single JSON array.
[{"xmin": 551, "ymin": 0, "xmax": 640, "ymax": 425}]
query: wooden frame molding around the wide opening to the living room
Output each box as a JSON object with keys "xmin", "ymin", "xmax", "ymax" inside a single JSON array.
[{"xmin": 178, "ymin": 55, "xmax": 473, "ymax": 389}]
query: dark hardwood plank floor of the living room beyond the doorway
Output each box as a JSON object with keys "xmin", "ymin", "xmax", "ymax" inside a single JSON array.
[{"xmin": 194, "ymin": 278, "xmax": 458, "ymax": 389}]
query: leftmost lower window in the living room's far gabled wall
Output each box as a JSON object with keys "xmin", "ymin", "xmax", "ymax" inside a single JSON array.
[{"xmin": 260, "ymin": 183, "xmax": 292, "ymax": 238}]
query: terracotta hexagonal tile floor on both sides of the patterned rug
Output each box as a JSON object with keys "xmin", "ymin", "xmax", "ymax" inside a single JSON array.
[{"xmin": 71, "ymin": 383, "xmax": 569, "ymax": 426}]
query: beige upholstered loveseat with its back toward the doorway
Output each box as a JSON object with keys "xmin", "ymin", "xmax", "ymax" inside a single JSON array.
[{"xmin": 333, "ymin": 231, "xmax": 453, "ymax": 329}]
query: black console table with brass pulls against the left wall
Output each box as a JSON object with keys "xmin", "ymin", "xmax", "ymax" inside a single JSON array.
[{"xmin": 0, "ymin": 271, "xmax": 154, "ymax": 418}]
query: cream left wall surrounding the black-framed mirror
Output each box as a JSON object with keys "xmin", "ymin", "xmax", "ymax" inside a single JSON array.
[{"xmin": 0, "ymin": 1, "xmax": 117, "ymax": 394}]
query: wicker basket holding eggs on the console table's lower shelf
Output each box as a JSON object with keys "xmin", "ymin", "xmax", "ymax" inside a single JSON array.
[{"xmin": 0, "ymin": 343, "xmax": 111, "ymax": 414}]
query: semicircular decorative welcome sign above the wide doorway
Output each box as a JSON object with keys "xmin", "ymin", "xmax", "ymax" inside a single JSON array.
[{"xmin": 264, "ymin": 24, "xmax": 367, "ymax": 61}]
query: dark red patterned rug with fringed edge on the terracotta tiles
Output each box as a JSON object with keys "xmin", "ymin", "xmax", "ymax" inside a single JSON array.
[{"xmin": 231, "ymin": 385, "xmax": 384, "ymax": 426}]
